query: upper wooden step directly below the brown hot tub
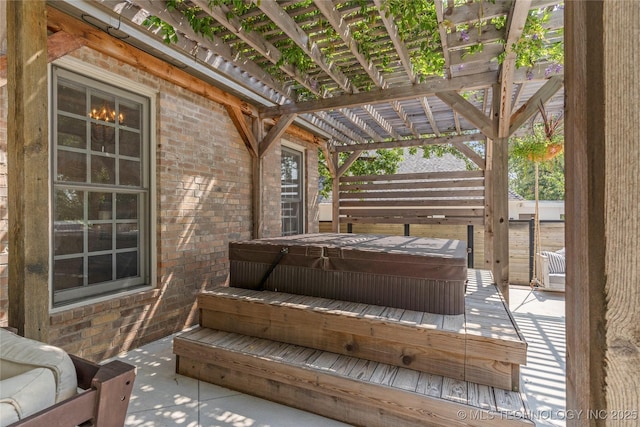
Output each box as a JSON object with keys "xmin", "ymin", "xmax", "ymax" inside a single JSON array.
[{"xmin": 198, "ymin": 273, "xmax": 526, "ymax": 389}]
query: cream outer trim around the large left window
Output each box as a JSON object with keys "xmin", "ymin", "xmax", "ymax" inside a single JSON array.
[{"xmin": 49, "ymin": 57, "xmax": 158, "ymax": 312}]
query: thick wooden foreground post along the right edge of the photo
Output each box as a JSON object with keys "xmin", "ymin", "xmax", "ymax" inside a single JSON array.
[{"xmin": 565, "ymin": 1, "xmax": 640, "ymax": 426}]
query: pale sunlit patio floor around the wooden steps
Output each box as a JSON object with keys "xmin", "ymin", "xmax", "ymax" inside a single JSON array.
[{"xmin": 110, "ymin": 287, "xmax": 566, "ymax": 427}]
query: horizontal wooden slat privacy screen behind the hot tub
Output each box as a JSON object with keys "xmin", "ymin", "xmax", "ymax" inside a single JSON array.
[{"xmin": 340, "ymin": 170, "xmax": 485, "ymax": 225}]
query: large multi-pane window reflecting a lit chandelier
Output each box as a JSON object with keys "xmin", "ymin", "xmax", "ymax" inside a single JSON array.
[{"xmin": 51, "ymin": 67, "xmax": 150, "ymax": 307}]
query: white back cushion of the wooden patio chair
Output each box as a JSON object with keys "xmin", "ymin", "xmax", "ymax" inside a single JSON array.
[{"xmin": 0, "ymin": 328, "xmax": 78, "ymax": 403}]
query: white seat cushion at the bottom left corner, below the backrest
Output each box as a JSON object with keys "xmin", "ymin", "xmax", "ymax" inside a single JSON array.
[{"xmin": 0, "ymin": 368, "xmax": 56, "ymax": 427}]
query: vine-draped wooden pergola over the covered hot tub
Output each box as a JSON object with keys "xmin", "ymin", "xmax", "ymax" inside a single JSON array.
[{"xmin": 38, "ymin": 0, "xmax": 563, "ymax": 298}]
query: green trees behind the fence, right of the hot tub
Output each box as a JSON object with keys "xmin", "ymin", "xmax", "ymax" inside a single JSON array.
[{"xmin": 509, "ymin": 154, "xmax": 565, "ymax": 200}]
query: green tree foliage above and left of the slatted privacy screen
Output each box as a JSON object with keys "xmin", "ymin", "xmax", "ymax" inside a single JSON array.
[{"xmin": 318, "ymin": 148, "xmax": 404, "ymax": 197}]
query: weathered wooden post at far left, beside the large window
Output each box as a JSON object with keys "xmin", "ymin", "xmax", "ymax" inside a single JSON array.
[{"xmin": 7, "ymin": 0, "xmax": 49, "ymax": 342}]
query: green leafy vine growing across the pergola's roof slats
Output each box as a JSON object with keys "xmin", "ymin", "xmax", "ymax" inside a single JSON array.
[{"xmin": 145, "ymin": 0, "xmax": 563, "ymax": 100}]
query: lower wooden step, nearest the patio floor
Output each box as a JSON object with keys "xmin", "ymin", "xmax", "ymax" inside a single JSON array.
[{"xmin": 174, "ymin": 328, "xmax": 534, "ymax": 427}]
